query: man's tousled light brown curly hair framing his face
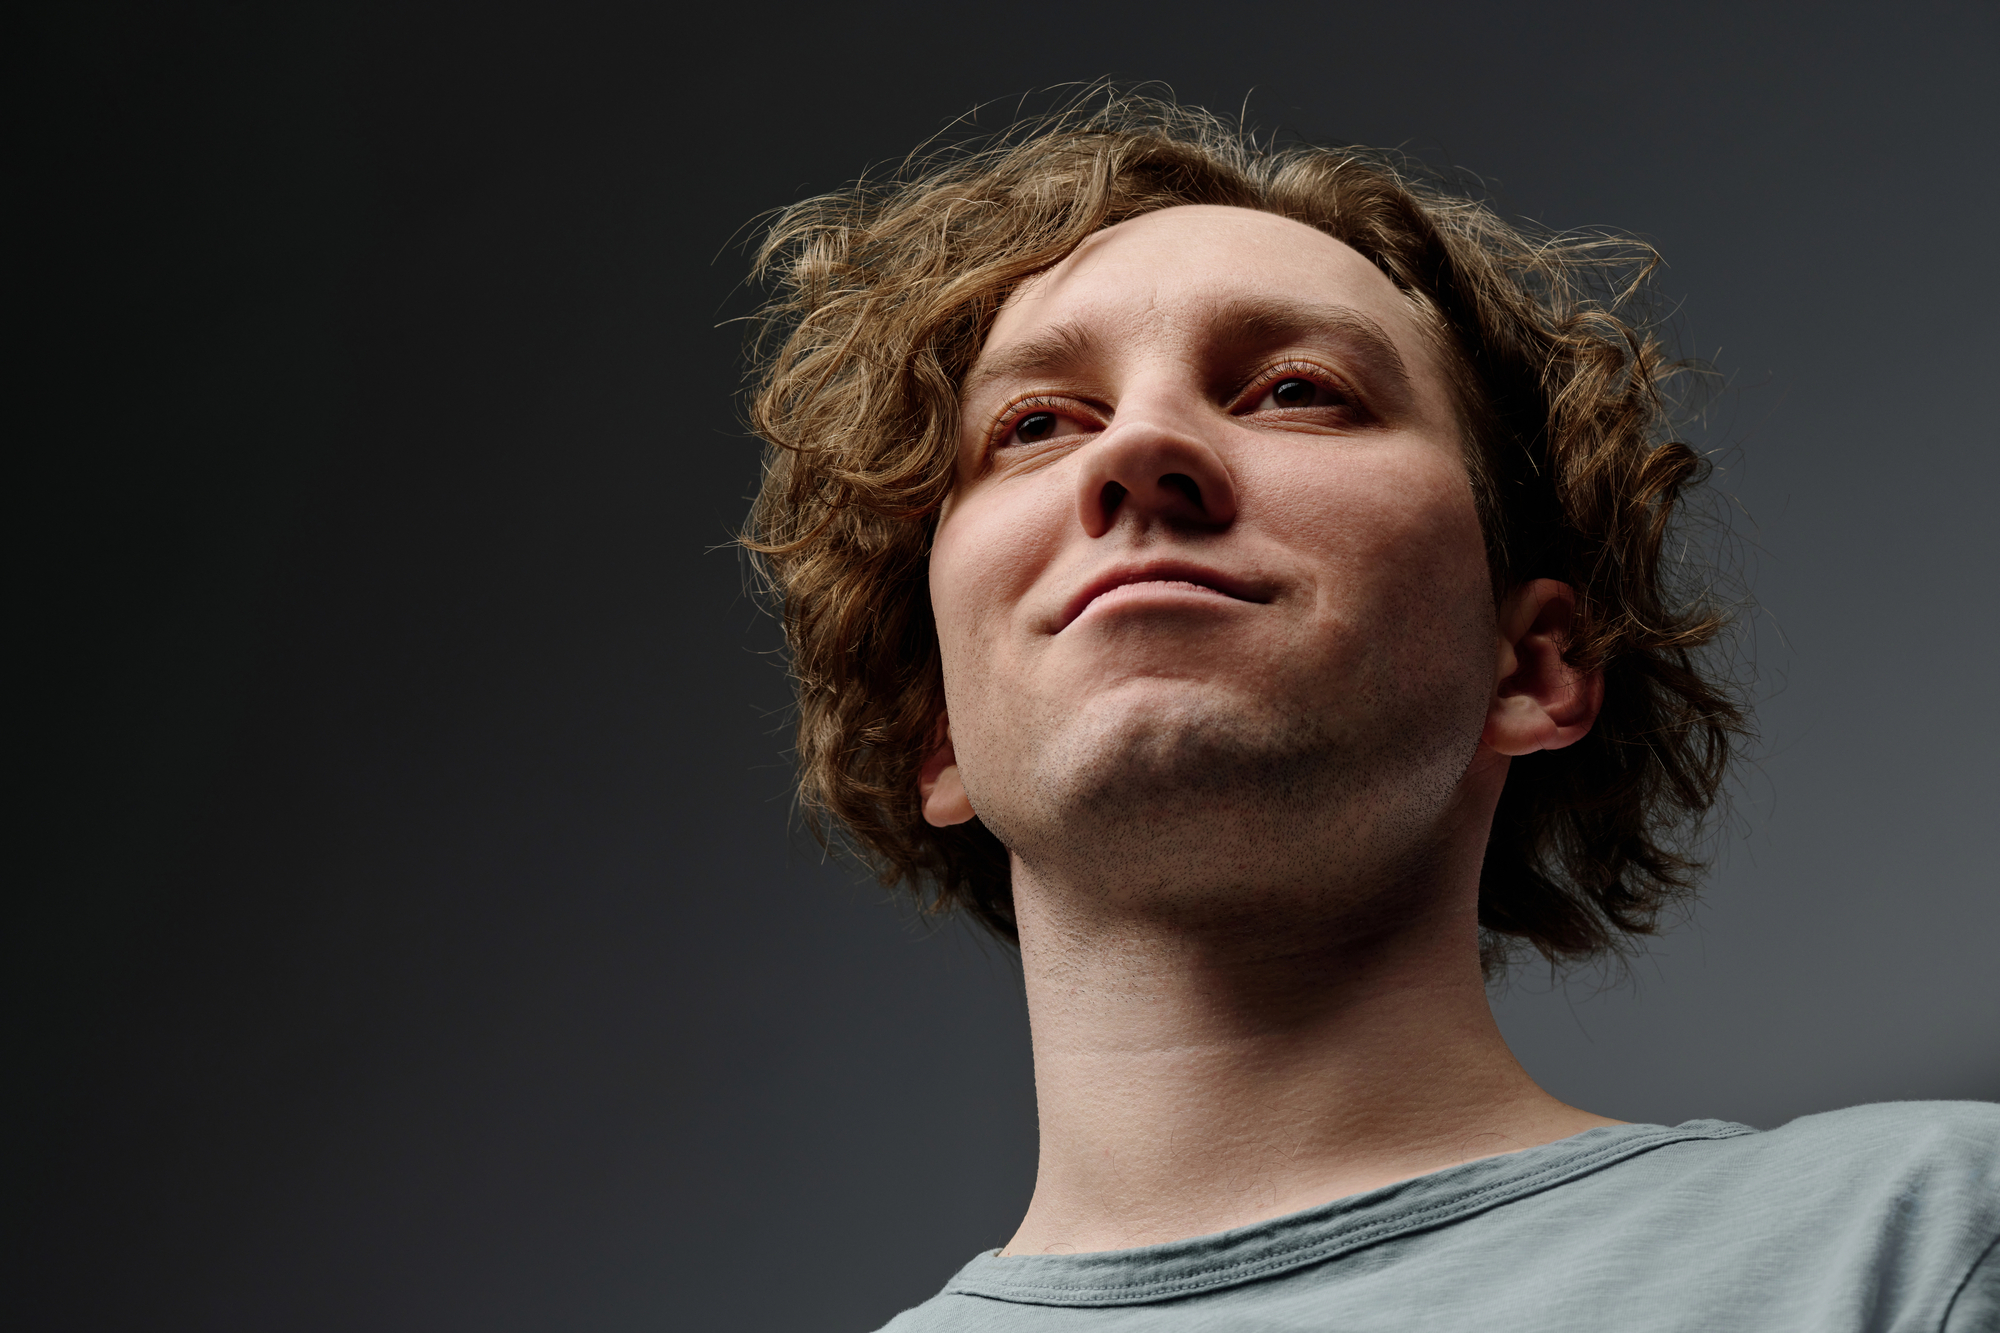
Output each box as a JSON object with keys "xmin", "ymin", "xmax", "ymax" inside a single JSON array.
[{"xmin": 742, "ymin": 92, "xmax": 1746, "ymax": 975}]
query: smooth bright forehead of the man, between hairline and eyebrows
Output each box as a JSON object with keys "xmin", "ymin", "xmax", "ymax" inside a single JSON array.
[{"xmin": 984, "ymin": 204, "xmax": 1428, "ymax": 364}]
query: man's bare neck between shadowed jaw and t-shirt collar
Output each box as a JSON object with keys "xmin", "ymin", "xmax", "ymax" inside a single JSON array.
[{"xmin": 1006, "ymin": 816, "xmax": 1616, "ymax": 1255}]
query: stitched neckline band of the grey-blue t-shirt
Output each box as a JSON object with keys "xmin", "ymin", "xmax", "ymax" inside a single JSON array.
[{"xmin": 944, "ymin": 1127, "xmax": 1756, "ymax": 1307}]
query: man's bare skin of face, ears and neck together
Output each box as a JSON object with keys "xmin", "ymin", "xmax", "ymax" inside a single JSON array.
[{"xmin": 920, "ymin": 206, "xmax": 1612, "ymax": 1253}]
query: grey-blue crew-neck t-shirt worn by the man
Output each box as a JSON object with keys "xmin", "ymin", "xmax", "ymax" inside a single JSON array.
[{"xmin": 882, "ymin": 1101, "xmax": 2000, "ymax": 1333}]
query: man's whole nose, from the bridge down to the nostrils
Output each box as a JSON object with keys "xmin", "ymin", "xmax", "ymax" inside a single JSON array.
[{"xmin": 1076, "ymin": 376, "xmax": 1236, "ymax": 536}]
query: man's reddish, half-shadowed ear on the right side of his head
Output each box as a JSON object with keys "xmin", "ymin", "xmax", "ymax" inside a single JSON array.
[{"xmin": 1480, "ymin": 578, "xmax": 1604, "ymax": 755}]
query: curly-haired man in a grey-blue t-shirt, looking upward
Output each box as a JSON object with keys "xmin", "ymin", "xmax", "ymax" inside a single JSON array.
[{"xmin": 750, "ymin": 100, "xmax": 2000, "ymax": 1333}]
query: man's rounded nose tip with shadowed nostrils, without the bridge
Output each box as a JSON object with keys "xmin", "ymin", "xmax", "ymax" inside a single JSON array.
[{"xmin": 1076, "ymin": 418, "xmax": 1236, "ymax": 536}]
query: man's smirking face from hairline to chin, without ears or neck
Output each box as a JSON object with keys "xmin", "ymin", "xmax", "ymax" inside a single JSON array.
[{"xmin": 930, "ymin": 206, "xmax": 1494, "ymax": 912}]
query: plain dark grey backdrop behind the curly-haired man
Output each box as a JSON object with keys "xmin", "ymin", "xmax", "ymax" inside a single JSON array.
[{"xmin": 19, "ymin": 2, "xmax": 2000, "ymax": 1331}]
